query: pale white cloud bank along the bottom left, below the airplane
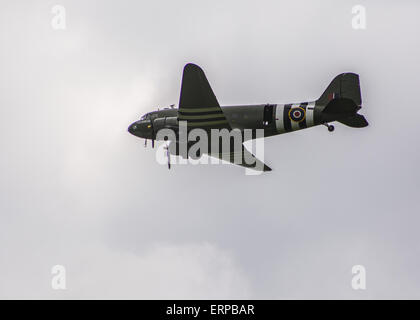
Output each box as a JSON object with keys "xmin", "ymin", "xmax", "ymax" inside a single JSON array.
[{"xmin": 0, "ymin": 243, "xmax": 250, "ymax": 299}]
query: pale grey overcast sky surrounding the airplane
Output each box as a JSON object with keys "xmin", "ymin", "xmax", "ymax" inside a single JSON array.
[{"xmin": 0, "ymin": 0, "xmax": 420, "ymax": 299}]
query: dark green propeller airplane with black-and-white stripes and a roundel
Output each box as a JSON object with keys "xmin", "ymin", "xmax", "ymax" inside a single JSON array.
[{"xmin": 128, "ymin": 63, "xmax": 368, "ymax": 171}]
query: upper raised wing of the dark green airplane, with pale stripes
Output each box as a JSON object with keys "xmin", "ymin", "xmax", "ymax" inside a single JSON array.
[{"xmin": 178, "ymin": 63, "xmax": 231, "ymax": 129}]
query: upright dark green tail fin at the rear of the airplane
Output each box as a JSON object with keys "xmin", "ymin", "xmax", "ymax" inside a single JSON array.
[{"xmin": 317, "ymin": 73, "xmax": 362, "ymax": 107}]
